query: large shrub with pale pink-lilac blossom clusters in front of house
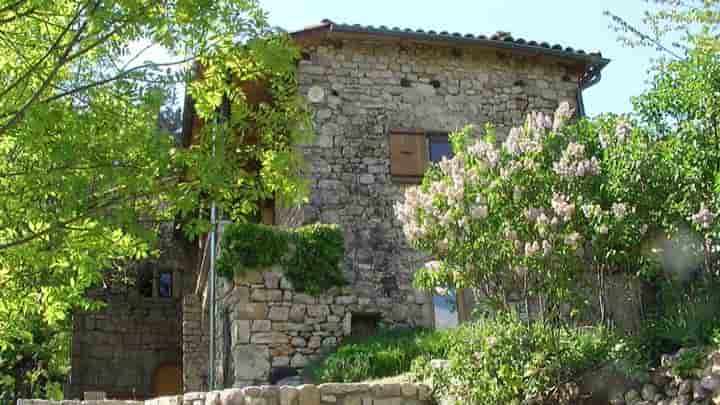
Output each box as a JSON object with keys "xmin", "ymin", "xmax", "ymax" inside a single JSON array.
[{"xmin": 397, "ymin": 103, "xmax": 658, "ymax": 315}]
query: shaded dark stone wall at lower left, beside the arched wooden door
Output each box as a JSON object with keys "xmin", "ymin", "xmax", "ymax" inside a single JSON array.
[{"xmin": 67, "ymin": 294, "xmax": 181, "ymax": 399}]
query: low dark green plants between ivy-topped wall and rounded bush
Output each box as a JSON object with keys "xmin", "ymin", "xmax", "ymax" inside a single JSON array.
[{"xmin": 306, "ymin": 329, "xmax": 451, "ymax": 383}]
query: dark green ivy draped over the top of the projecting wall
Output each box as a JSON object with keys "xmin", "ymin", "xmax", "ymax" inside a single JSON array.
[{"xmin": 217, "ymin": 223, "xmax": 346, "ymax": 295}]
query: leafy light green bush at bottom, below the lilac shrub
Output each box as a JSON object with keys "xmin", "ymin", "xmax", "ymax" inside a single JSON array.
[{"xmin": 413, "ymin": 315, "xmax": 616, "ymax": 404}]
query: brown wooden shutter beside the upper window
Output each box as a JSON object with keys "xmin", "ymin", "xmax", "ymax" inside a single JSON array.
[{"xmin": 390, "ymin": 129, "xmax": 428, "ymax": 183}]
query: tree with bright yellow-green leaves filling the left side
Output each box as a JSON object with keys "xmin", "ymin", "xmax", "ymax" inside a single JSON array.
[{"xmin": 0, "ymin": 0, "xmax": 311, "ymax": 400}]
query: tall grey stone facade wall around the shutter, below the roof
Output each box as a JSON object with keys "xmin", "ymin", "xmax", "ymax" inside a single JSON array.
[{"xmin": 296, "ymin": 40, "xmax": 578, "ymax": 325}]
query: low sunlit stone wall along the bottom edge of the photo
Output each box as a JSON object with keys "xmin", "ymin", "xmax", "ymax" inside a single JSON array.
[{"xmin": 18, "ymin": 384, "xmax": 432, "ymax": 405}]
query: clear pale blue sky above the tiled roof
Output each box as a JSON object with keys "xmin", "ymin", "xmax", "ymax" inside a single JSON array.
[{"xmin": 260, "ymin": 0, "xmax": 657, "ymax": 115}]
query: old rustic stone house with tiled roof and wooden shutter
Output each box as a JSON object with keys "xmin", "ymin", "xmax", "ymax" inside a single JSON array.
[{"xmin": 68, "ymin": 20, "xmax": 609, "ymax": 398}]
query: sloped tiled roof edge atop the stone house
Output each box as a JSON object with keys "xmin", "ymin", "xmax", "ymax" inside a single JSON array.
[{"xmin": 291, "ymin": 19, "xmax": 610, "ymax": 69}]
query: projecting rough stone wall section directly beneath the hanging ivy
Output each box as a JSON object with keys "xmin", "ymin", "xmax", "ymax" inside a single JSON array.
[{"xmin": 211, "ymin": 267, "xmax": 432, "ymax": 388}]
